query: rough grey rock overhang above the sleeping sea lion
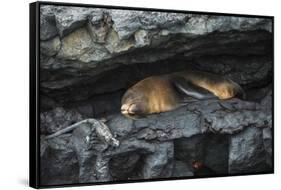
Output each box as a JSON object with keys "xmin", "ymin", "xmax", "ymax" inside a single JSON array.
[{"xmin": 40, "ymin": 6, "xmax": 272, "ymax": 104}]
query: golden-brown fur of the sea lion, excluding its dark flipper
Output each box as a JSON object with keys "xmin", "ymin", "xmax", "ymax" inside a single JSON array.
[{"xmin": 121, "ymin": 71, "xmax": 241, "ymax": 118}]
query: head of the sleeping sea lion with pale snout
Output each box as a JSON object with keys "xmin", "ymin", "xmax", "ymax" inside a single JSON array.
[{"xmin": 121, "ymin": 88, "xmax": 148, "ymax": 119}]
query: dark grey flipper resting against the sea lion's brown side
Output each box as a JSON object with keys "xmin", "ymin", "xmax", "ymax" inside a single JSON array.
[{"xmin": 173, "ymin": 77, "xmax": 217, "ymax": 100}]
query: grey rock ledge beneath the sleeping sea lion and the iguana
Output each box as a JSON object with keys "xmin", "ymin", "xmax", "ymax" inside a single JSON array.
[{"xmin": 41, "ymin": 90, "xmax": 272, "ymax": 184}]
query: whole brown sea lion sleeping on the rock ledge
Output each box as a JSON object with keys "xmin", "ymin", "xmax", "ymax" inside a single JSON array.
[{"xmin": 121, "ymin": 70, "xmax": 245, "ymax": 119}]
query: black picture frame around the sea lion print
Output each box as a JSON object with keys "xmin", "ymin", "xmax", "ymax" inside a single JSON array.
[{"xmin": 29, "ymin": 1, "xmax": 274, "ymax": 188}]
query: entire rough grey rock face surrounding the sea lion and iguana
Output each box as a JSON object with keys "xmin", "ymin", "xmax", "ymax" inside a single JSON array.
[{"xmin": 40, "ymin": 5, "xmax": 273, "ymax": 185}]
